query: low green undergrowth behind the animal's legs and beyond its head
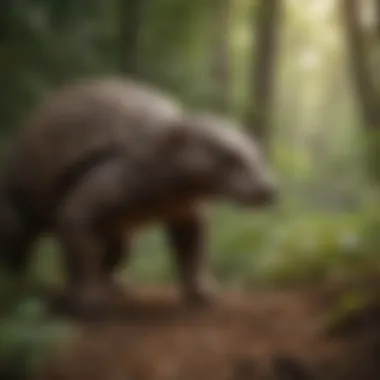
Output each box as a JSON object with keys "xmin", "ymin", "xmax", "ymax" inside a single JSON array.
[{"xmin": 27, "ymin": 197, "xmax": 380, "ymax": 287}]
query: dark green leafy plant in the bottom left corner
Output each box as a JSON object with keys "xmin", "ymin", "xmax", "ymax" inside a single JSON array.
[{"xmin": 0, "ymin": 273, "xmax": 76, "ymax": 379}]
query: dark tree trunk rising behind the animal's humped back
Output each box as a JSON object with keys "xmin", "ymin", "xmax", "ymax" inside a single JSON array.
[{"xmin": 120, "ymin": 0, "xmax": 143, "ymax": 76}]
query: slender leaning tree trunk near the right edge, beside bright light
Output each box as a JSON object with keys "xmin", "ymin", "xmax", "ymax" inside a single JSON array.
[{"xmin": 342, "ymin": 0, "xmax": 380, "ymax": 130}]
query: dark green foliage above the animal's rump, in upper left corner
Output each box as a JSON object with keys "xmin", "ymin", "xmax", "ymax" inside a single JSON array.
[{"xmin": 0, "ymin": 0, "xmax": 117, "ymax": 134}]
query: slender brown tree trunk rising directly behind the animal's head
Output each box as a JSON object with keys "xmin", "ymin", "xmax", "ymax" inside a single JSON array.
[{"xmin": 246, "ymin": 0, "xmax": 282, "ymax": 146}]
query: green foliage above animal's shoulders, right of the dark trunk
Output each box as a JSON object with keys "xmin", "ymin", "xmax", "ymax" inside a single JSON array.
[{"xmin": 141, "ymin": 0, "xmax": 221, "ymax": 106}]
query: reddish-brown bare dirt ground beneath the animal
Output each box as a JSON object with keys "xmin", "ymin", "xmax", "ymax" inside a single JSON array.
[{"xmin": 41, "ymin": 286, "xmax": 380, "ymax": 380}]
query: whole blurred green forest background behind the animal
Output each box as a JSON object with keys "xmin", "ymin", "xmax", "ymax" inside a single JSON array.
[{"xmin": 0, "ymin": 0, "xmax": 380, "ymax": 378}]
